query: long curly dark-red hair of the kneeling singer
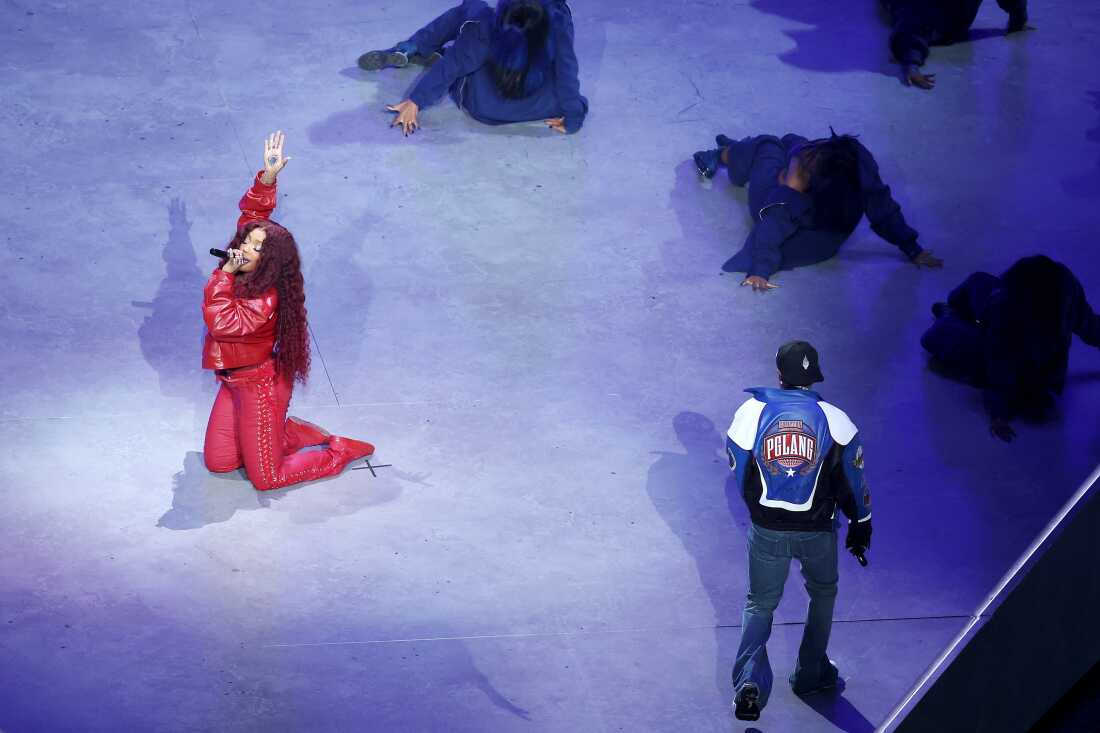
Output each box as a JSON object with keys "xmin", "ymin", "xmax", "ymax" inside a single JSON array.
[{"xmin": 227, "ymin": 221, "xmax": 309, "ymax": 383}]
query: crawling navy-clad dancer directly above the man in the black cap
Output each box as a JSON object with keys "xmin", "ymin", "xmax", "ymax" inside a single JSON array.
[{"xmin": 694, "ymin": 133, "xmax": 943, "ymax": 291}]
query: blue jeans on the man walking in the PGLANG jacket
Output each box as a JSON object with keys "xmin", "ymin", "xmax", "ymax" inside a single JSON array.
[{"xmin": 734, "ymin": 524, "xmax": 838, "ymax": 708}]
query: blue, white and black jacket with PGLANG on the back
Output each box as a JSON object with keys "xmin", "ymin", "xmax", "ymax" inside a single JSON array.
[{"xmin": 726, "ymin": 387, "xmax": 871, "ymax": 532}]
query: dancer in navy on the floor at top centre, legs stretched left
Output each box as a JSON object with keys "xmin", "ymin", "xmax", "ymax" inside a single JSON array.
[{"xmin": 359, "ymin": 0, "xmax": 589, "ymax": 135}]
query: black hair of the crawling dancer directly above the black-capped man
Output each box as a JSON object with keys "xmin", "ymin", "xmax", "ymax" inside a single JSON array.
[{"xmin": 795, "ymin": 129, "xmax": 864, "ymax": 232}]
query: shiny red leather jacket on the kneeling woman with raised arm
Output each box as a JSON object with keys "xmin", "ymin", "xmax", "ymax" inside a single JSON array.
[{"xmin": 202, "ymin": 171, "xmax": 278, "ymax": 369}]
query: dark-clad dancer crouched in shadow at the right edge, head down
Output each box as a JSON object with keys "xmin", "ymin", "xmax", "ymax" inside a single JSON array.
[{"xmin": 921, "ymin": 254, "xmax": 1100, "ymax": 441}]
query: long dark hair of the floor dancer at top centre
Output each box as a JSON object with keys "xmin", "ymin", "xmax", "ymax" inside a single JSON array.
[{"xmin": 490, "ymin": 0, "xmax": 550, "ymax": 99}]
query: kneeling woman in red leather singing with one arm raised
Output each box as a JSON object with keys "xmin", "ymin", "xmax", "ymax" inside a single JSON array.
[{"xmin": 202, "ymin": 132, "xmax": 374, "ymax": 491}]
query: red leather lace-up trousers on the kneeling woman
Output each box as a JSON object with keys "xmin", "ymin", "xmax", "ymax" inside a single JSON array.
[{"xmin": 204, "ymin": 360, "xmax": 348, "ymax": 491}]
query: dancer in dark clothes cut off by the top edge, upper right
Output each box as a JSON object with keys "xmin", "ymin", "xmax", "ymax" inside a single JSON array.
[{"xmin": 882, "ymin": 0, "xmax": 1031, "ymax": 89}]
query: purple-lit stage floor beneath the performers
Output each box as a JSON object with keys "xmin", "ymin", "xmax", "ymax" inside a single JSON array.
[{"xmin": 0, "ymin": 0, "xmax": 1100, "ymax": 733}]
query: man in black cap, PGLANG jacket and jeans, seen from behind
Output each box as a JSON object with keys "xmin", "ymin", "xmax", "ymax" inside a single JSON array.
[{"xmin": 726, "ymin": 341, "xmax": 871, "ymax": 720}]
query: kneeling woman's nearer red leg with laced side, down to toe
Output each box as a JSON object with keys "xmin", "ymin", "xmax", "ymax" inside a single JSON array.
[{"xmin": 227, "ymin": 362, "xmax": 374, "ymax": 491}]
